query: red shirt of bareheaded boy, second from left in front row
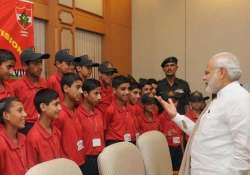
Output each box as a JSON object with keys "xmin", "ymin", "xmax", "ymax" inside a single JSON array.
[{"xmin": 27, "ymin": 121, "xmax": 64, "ymax": 167}]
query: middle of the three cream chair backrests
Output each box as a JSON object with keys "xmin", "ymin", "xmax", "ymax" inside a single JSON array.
[{"xmin": 98, "ymin": 142, "xmax": 145, "ymax": 175}]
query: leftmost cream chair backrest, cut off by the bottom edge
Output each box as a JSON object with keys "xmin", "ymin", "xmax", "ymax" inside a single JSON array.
[{"xmin": 25, "ymin": 158, "xmax": 82, "ymax": 175}]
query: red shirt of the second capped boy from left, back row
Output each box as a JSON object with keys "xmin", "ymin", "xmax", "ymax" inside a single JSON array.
[{"xmin": 48, "ymin": 73, "xmax": 64, "ymax": 102}]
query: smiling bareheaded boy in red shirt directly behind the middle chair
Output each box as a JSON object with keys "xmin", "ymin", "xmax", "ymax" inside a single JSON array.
[{"xmin": 105, "ymin": 75, "xmax": 137, "ymax": 145}]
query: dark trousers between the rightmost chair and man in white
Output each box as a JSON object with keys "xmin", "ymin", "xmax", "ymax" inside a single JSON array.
[{"xmin": 169, "ymin": 146, "xmax": 183, "ymax": 171}]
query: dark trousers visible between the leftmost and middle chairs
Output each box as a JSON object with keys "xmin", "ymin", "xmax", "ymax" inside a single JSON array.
[{"xmin": 80, "ymin": 156, "xmax": 99, "ymax": 175}]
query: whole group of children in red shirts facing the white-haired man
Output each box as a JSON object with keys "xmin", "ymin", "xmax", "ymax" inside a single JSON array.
[{"xmin": 0, "ymin": 49, "xmax": 206, "ymax": 175}]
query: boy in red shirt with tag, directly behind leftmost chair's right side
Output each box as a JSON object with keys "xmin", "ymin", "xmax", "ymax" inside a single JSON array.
[{"xmin": 54, "ymin": 73, "xmax": 85, "ymax": 172}]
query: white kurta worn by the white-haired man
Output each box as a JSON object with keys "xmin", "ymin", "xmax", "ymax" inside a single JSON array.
[{"xmin": 173, "ymin": 82, "xmax": 250, "ymax": 175}]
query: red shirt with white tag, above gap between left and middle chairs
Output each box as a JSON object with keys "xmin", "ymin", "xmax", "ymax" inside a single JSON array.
[{"xmin": 76, "ymin": 104, "xmax": 105, "ymax": 155}]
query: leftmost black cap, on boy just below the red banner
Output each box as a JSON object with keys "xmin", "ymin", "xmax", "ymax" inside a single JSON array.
[{"xmin": 20, "ymin": 48, "xmax": 50, "ymax": 63}]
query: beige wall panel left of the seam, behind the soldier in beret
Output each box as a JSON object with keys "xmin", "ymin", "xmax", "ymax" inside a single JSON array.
[{"xmin": 132, "ymin": 0, "xmax": 185, "ymax": 79}]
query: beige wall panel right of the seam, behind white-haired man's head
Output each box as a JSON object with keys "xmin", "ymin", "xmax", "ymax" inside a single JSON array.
[{"xmin": 186, "ymin": 0, "xmax": 250, "ymax": 94}]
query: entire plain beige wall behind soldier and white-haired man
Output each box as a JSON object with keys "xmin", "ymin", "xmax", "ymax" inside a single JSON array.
[{"xmin": 132, "ymin": 0, "xmax": 250, "ymax": 91}]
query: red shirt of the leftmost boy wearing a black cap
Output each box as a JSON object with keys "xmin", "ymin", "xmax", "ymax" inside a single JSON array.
[{"xmin": 12, "ymin": 76, "xmax": 48, "ymax": 123}]
